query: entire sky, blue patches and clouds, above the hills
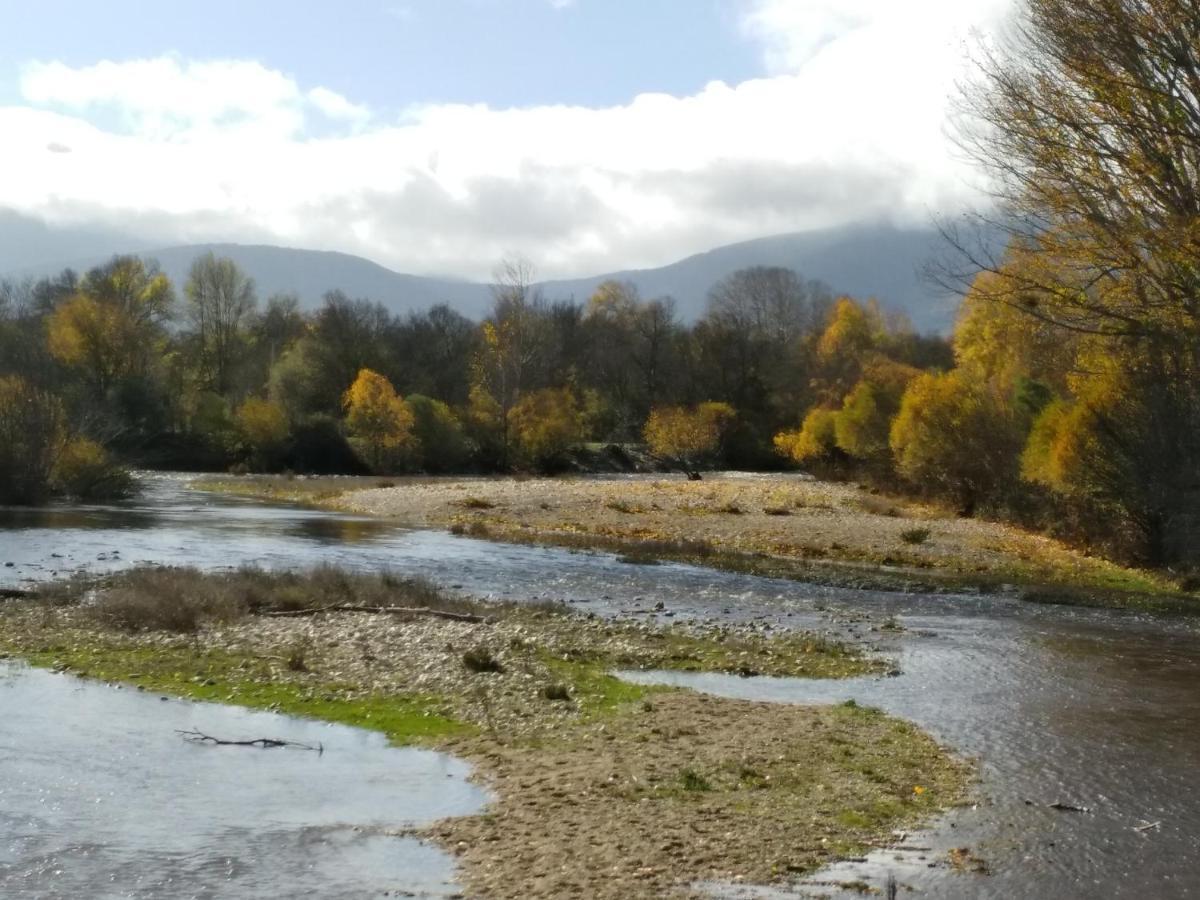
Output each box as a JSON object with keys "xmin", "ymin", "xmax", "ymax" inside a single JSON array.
[{"xmin": 0, "ymin": 0, "xmax": 1014, "ymax": 277}]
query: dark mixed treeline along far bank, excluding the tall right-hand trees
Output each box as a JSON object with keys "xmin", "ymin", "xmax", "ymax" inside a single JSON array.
[{"xmin": 0, "ymin": 254, "xmax": 950, "ymax": 496}]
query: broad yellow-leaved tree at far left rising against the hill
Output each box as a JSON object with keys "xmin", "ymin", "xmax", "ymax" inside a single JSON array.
[{"xmin": 47, "ymin": 257, "xmax": 173, "ymax": 400}]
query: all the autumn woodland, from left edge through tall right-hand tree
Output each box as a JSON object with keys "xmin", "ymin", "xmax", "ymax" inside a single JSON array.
[{"xmin": 7, "ymin": 0, "xmax": 1200, "ymax": 578}]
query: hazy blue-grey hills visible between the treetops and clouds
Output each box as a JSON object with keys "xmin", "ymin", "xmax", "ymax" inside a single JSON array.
[{"xmin": 7, "ymin": 226, "xmax": 958, "ymax": 331}]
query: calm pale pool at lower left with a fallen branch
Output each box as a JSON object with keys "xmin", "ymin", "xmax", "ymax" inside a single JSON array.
[{"xmin": 0, "ymin": 665, "xmax": 486, "ymax": 900}]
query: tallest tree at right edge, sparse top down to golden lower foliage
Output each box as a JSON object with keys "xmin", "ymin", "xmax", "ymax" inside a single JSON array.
[{"xmin": 950, "ymin": 0, "xmax": 1200, "ymax": 559}]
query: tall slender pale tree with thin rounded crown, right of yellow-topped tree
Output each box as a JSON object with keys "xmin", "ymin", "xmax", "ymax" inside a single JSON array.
[{"xmin": 184, "ymin": 252, "xmax": 258, "ymax": 396}]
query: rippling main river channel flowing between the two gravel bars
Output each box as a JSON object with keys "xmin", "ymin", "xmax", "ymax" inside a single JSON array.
[{"xmin": 0, "ymin": 476, "xmax": 1200, "ymax": 899}]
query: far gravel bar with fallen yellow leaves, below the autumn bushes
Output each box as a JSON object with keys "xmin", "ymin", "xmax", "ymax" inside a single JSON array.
[{"xmin": 198, "ymin": 474, "xmax": 1200, "ymax": 613}]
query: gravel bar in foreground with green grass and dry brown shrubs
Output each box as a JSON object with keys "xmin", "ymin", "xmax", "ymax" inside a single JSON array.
[{"xmin": 0, "ymin": 570, "xmax": 970, "ymax": 898}]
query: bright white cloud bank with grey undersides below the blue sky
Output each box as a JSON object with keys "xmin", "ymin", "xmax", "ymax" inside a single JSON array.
[{"xmin": 0, "ymin": 0, "xmax": 1010, "ymax": 276}]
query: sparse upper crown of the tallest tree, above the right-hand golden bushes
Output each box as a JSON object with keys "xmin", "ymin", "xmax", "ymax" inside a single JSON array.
[{"xmin": 956, "ymin": 0, "xmax": 1200, "ymax": 359}]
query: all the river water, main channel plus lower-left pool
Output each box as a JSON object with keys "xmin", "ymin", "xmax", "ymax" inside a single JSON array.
[{"xmin": 0, "ymin": 475, "xmax": 1200, "ymax": 900}]
